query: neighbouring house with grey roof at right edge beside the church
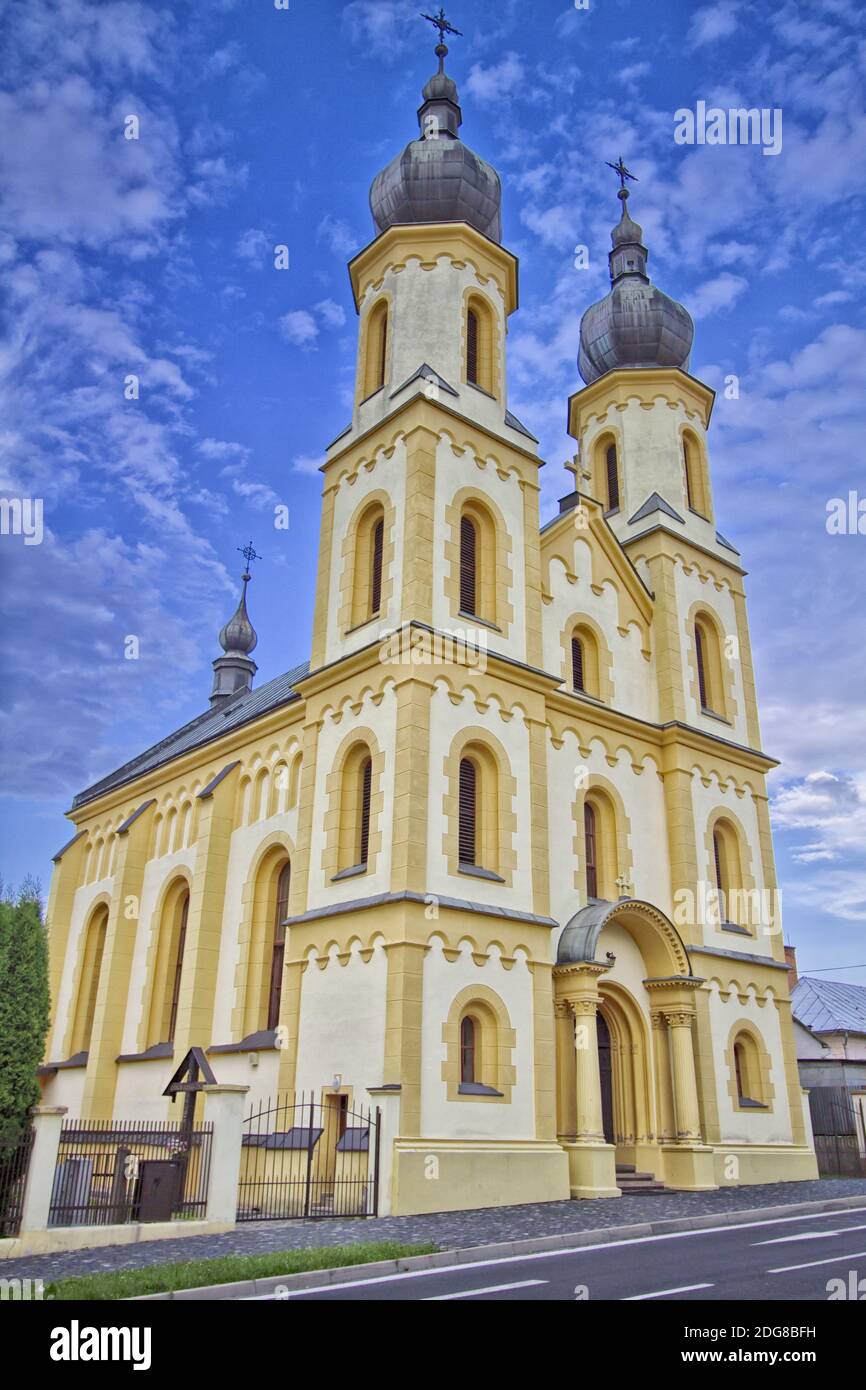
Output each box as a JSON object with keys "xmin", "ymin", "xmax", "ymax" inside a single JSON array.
[{"xmin": 788, "ymin": 967, "xmax": 866, "ymax": 1173}]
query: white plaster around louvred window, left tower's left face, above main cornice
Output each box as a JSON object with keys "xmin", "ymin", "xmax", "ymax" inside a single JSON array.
[{"xmin": 325, "ymin": 438, "xmax": 406, "ymax": 663}]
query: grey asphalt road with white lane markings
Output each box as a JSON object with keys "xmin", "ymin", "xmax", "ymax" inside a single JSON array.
[{"xmin": 257, "ymin": 1205, "xmax": 866, "ymax": 1301}]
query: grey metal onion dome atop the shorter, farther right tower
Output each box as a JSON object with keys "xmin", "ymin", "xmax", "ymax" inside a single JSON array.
[{"xmin": 577, "ymin": 188, "xmax": 695, "ymax": 385}]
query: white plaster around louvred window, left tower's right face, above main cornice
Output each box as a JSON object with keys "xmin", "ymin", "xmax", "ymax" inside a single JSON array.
[{"xmin": 432, "ymin": 438, "xmax": 527, "ymax": 662}]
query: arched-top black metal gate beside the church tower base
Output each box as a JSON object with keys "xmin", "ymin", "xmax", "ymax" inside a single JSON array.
[{"xmin": 238, "ymin": 1091, "xmax": 379, "ymax": 1222}]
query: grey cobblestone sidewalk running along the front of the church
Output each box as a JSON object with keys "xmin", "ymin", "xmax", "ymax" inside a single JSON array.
[{"xmin": 0, "ymin": 1179, "xmax": 866, "ymax": 1280}]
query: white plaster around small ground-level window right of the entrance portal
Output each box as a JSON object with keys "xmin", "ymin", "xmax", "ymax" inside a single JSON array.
[{"xmin": 706, "ymin": 980, "xmax": 794, "ymax": 1144}]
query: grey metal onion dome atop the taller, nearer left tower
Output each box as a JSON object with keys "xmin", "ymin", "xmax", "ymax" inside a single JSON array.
[{"xmin": 370, "ymin": 43, "xmax": 502, "ymax": 242}]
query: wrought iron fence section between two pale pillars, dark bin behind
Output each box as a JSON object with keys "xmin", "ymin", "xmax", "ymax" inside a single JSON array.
[{"xmin": 49, "ymin": 1120, "xmax": 213, "ymax": 1226}]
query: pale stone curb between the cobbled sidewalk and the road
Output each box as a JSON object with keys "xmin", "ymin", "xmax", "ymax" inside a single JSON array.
[{"xmin": 122, "ymin": 1195, "xmax": 866, "ymax": 1302}]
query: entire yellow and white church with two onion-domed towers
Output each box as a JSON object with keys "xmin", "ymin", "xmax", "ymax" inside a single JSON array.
[{"xmin": 42, "ymin": 44, "xmax": 816, "ymax": 1212}]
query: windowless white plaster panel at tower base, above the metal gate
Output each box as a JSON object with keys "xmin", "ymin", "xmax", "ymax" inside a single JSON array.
[{"xmin": 296, "ymin": 938, "xmax": 388, "ymax": 1104}]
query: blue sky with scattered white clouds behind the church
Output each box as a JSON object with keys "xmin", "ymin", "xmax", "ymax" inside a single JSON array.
[{"xmin": 0, "ymin": 0, "xmax": 866, "ymax": 984}]
